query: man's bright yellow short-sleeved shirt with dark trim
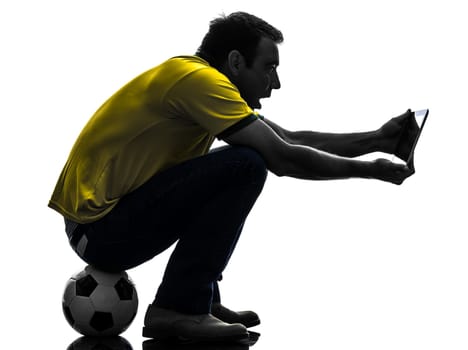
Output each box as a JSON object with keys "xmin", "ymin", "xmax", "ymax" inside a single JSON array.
[{"xmin": 49, "ymin": 56, "xmax": 257, "ymax": 223}]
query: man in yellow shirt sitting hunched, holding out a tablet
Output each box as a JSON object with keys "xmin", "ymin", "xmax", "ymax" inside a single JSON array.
[{"xmin": 49, "ymin": 12, "xmax": 414, "ymax": 340}]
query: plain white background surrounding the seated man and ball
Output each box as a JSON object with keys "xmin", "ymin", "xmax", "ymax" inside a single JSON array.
[{"xmin": 0, "ymin": 0, "xmax": 468, "ymax": 350}]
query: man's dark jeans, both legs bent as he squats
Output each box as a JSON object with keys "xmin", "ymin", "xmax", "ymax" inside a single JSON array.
[{"xmin": 66, "ymin": 147, "xmax": 267, "ymax": 314}]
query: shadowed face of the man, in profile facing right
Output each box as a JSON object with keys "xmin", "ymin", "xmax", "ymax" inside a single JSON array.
[{"xmin": 236, "ymin": 38, "xmax": 281, "ymax": 109}]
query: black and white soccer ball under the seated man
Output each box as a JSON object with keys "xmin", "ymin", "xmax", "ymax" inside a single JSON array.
[{"xmin": 62, "ymin": 265, "xmax": 138, "ymax": 336}]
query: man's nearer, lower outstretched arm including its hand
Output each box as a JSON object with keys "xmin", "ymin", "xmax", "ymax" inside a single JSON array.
[{"xmin": 225, "ymin": 120, "xmax": 411, "ymax": 184}]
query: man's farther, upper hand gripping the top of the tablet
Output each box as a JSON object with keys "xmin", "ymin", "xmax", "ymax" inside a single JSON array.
[{"xmin": 379, "ymin": 109, "xmax": 419, "ymax": 161}]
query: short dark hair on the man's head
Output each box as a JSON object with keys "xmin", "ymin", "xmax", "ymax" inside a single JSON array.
[{"xmin": 196, "ymin": 12, "xmax": 283, "ymax": 69}]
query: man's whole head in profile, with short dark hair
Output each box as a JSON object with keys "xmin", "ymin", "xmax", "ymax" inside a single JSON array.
[{"xmin": 197, "ymin": 12, "xmax": 283, "ymax": 108}]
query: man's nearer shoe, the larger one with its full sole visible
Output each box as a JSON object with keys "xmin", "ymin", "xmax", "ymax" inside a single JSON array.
[{"xmin": 143, "ymin": 305, "xmax": 249, "ymax": 341}]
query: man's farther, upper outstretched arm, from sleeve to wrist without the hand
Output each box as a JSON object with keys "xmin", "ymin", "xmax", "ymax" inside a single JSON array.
[{"xmin": 265, "ymin": 118, "xmax": 383, "ymax": 157}]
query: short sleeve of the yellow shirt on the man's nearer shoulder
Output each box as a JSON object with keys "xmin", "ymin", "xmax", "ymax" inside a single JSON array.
[{"xmin": 168, "ymin": 67, "xmax": 256, "ymax": 136}]
